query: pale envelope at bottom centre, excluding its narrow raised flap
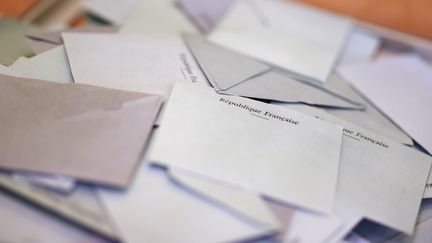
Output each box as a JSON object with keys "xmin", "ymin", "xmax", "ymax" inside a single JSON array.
[{"xmin": 99, "ymin": 164, "xmax": 278, "ymax": 243}]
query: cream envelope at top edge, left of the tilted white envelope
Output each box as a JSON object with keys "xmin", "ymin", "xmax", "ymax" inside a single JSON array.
[{"xmin": 120, "ymin": 0, "xmax": 197, "ymax": 35}]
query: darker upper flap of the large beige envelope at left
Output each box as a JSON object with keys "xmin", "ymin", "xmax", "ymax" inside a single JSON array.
[{"xmin": 0, "ymin": 75, "xmax": 153, "ymax": 120}]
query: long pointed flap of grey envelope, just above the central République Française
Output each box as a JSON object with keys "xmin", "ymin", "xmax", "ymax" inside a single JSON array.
[{"xmin": 224, "ymin": 72, "xmax": 363, "ymax": 109}]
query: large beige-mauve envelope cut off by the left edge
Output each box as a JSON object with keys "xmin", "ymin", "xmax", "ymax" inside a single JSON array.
[{"xmin": 0, "ymin": 76, "xmax": 160, "ymax": 187}]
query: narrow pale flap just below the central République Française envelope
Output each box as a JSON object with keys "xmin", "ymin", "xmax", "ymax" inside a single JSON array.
[{"xmin": 169, "ymin": 169, "xmax": 280, "ymax": 230}]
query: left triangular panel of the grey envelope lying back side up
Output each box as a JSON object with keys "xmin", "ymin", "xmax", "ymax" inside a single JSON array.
[{"xmin": 184, "ymin": 34, "xmax": 270, "ymax": 90}]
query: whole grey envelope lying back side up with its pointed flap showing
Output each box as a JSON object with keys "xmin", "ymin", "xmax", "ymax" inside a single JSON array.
[{"xmin": 184, "ymin": 34, "xmax": 364, "ymax": 109}]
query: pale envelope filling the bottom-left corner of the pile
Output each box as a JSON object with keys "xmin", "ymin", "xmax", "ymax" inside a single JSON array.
[{"xmin": 0, "ymin": 191, "xmax": 111, "ymax": 243}]
